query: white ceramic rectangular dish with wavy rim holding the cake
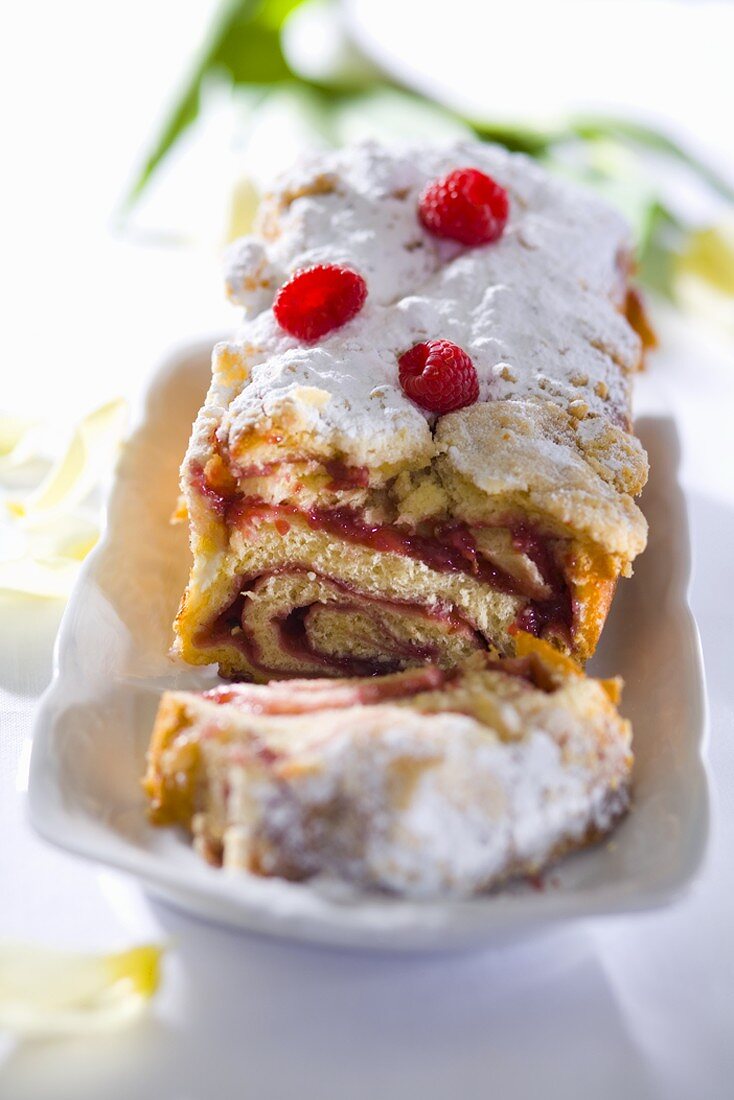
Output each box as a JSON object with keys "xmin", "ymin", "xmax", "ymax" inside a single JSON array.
[{"xmin": 29, "ymin": 348, "xmax": 709, "ymax": 949}]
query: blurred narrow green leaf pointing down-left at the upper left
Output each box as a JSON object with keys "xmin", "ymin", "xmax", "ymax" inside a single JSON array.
[{"xmin": 123, "ymin": 0, "xmax": 303, "ymax": 209}]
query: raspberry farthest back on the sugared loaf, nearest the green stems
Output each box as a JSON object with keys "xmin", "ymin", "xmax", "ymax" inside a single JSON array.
[{"xmin": 418, "ymin": 168, "xmax": 510, "ymax": 244}]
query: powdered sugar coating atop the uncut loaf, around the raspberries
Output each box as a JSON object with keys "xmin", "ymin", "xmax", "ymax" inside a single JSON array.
[{"xmin": 210, "ymin": 142, "xmax": 639, "ymax": 465}]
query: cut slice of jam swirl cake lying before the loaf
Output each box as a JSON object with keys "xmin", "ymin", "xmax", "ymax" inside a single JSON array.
[{"xmin": 144, "ymin": 635, "xmax": 632, "ymax": 898}]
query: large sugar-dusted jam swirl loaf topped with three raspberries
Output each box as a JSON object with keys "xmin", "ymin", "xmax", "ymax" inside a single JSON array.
[{"xmin": 176, "ymin": 143, "xmax": 647, "ymax": 680}]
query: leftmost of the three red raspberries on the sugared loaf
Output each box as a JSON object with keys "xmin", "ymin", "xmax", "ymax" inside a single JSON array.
[{"xmin": 273, "ymin": 264, "xmax": 366, "ymax": 343}]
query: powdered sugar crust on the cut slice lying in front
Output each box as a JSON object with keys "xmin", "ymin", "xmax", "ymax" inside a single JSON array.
[{"xmin": 206, "ymin": 692, "xmax": 628, "ymax": 898}]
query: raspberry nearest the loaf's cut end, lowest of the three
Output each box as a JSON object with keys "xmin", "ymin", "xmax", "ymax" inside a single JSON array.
[{"xmin": 397, "ymin": 340, "xmax": 479, "ymax": 415}]
